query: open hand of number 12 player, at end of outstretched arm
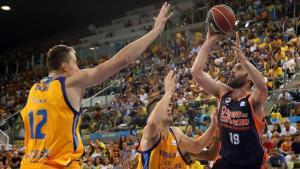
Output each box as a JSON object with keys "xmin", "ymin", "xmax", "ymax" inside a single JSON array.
[{"xmin": 153, "ymin": 2, "xmax": 173, "ymax": 33}]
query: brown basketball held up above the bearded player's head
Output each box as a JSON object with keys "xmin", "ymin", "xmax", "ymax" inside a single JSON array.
[{"xmin": 206, "ymin": 5, "xmax": 236, "ymax": 34}]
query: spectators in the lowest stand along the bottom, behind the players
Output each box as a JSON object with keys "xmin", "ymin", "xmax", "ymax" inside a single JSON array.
[{"xmin": 0, "ymin": 120, "xmax": 300, "ymax": 169}]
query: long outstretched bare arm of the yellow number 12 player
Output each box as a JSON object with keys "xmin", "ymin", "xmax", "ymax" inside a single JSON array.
[{"xmin": 67, "ymin": 3, "xmax": 172, "ymax": 89}]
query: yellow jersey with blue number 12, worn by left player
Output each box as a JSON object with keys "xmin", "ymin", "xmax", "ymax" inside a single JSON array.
[{"xmin": 21, "ymin": 77, "xmax": 84, "ymax": 169}]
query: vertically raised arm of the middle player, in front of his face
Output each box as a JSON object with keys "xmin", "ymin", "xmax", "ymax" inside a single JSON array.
[{"xmin": 142, "ymin": 70, "xmax": 176, "ymax": 142}]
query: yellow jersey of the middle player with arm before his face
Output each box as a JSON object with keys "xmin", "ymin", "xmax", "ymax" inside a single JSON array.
[{"xmin": 137, "ymin": 128, "xmax": 187, "ymax": 169}]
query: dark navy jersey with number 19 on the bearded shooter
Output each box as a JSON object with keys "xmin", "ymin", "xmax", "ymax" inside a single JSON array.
[{"xmin": 218, "ymin": 91, "xmax": 264, "ymax": 166}]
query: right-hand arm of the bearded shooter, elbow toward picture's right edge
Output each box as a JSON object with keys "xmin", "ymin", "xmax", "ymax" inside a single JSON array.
[{"xmin": 232, "ymin": 32, "xmax": 268, "ymax": 119}]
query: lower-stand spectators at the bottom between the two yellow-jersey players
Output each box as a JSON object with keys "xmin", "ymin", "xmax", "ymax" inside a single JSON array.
[{"xmin": 80, "ymin": 136, "xmax": 139, "ymax": 169}]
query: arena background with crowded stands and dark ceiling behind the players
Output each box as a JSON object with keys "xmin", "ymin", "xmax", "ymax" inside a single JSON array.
[{"xmin": 0, "ymin": 0, "xmax": 300, "ymax": 169}]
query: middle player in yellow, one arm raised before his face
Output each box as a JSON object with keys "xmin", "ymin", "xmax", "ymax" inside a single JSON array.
[{"xmin": 137, "ymin": 70, "xmax": 219, "ymax": 169}]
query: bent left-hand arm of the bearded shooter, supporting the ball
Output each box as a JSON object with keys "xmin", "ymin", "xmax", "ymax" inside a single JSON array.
[{"xmin": 192, "ymin": 30, "xmax": 227, "ymax": 98}]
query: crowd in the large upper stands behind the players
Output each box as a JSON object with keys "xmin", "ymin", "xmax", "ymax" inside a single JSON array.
[{"xmin": 0, "ymin": 0, "xmax": 300, "ymax": 135}]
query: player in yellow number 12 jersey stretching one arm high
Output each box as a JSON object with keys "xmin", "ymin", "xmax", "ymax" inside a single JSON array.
[{"xmin": 21, "ymin": 3, "xmax": 172, "ymax": 169}]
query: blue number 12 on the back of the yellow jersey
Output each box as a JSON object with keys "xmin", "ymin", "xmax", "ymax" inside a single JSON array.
[{"xmin": 28, "ymin": 109, "xmax": 47, "ymax": 139}]
